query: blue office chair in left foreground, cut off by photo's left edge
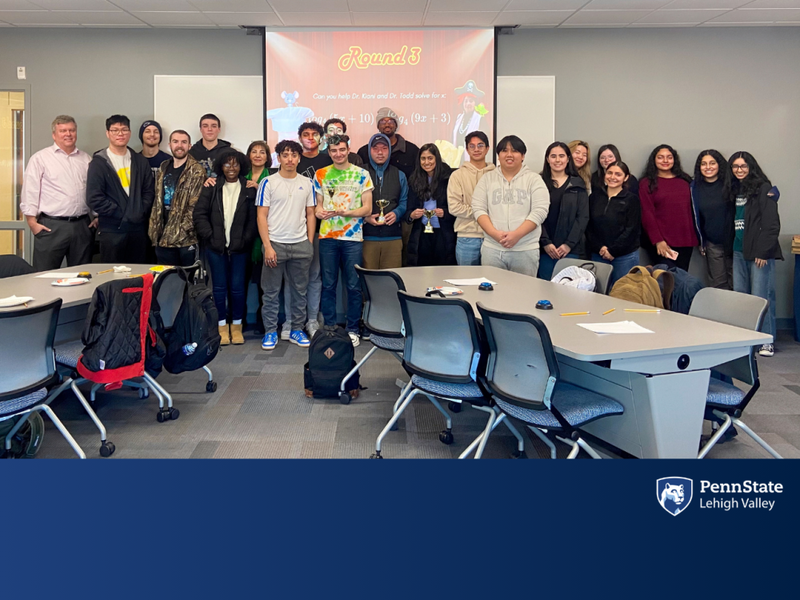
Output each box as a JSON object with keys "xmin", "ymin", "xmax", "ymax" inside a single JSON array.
[{"xmin": 0, "ymin": 298, "xmax": 86, "ymax": 458}]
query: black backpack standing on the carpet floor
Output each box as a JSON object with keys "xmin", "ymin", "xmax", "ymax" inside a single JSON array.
[{"xmin": 304, "ymin": 327, "xmax": 361, "ymax": 403}]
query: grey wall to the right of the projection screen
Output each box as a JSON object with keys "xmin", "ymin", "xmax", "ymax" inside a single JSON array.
[{"xmin": 497, "ymin": 27, "xmax": 800, "ymax": 326}]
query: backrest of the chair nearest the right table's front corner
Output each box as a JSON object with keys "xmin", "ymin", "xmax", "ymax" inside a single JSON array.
[{"xmin": 478, "ymin": 302, "xmax": 559, "ymax": 410}]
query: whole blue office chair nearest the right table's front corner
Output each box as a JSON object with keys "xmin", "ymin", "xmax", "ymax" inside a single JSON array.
[{"xmin": 478, "ymin": 303, "xmax": 624, "ymax": 458}]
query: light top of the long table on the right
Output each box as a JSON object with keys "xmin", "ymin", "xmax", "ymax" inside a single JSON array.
[{"xmin": 393, "ymin": 266, "xmax": 772, "ymax": 361}]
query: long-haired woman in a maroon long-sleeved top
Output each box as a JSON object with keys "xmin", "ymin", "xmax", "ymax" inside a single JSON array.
[{"xmin": 639, "ymin": 144, "xmax": 697, "ymax": 271}]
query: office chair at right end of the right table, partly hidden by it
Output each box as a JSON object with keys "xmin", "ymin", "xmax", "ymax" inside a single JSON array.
[{"xmin": 689, "ymin": 288, "xmax": 783, "ymax": 458}]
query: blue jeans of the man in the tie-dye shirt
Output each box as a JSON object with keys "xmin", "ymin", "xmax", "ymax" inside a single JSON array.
[{"xmin": 319, "ymin": 239, "xmax": 363, "ymax": 333}]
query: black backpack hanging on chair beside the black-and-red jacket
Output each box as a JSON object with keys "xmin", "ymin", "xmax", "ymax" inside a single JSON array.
[{"xmin": 153, "ymin": 267, "xmax": 221, "ymax": 374}]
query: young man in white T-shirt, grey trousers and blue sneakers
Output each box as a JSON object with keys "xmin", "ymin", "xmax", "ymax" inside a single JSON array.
[{"xmin": 256, "ymin": 140, "xmax": 316, "ymax": 350}]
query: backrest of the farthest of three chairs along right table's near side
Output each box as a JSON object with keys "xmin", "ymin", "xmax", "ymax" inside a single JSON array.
[{"xmin": 356, "ymin": 265, "xmax": 406, "ymax": 337}]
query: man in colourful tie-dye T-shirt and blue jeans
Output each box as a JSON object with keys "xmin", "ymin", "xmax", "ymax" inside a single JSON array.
[{"xmin": 309, "ymin": 135, "xmax": 372, "ymax": 346}]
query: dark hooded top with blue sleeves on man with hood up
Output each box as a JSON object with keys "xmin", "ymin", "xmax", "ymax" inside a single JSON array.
[{"xmin": 364, "ymin": 133, "xmax": 408, "ymax": 242}]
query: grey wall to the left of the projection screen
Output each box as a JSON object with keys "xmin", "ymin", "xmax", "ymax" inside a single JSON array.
[{"xmin": 0, "ymin": 27, "xmax": 263, "ymax": 154}]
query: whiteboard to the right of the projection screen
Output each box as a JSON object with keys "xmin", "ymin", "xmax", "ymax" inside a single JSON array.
[{"xmin": 495, "ymin": 76, "xmax": 556, "ymax": 173}]
